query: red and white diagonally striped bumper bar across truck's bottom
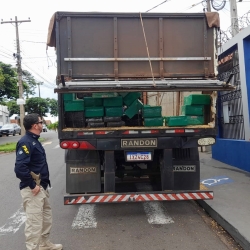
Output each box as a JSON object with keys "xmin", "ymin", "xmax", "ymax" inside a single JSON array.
[{"xmin": 64, "ymin": 191, "xmax": 214, "ymax": 205}]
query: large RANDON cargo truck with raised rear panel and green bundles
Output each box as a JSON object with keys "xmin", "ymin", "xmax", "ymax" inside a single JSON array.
[{"xmin": 47, "ymin": 11, "xmax": 233, "ymax": 205}]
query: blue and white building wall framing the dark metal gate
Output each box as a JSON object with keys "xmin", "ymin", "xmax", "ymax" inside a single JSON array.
[{"xmin": 212, "ymin": 26, "xmax": 250, "ymax": 172}]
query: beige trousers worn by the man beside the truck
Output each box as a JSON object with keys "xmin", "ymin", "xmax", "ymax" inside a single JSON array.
[{"xmin": 21, "ymin": 186, "xmax": 52, "ymax": 250}]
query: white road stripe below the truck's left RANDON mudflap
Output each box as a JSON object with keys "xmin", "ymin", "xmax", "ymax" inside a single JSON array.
[{"xmin": 71, "ymin": 204, "xmax": 97, "ymax": 229}]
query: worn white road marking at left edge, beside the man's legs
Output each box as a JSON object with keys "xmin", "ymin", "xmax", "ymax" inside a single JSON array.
[{"xmin": 0, "ymin": 207, "xmax": 26, "ymax": 235}]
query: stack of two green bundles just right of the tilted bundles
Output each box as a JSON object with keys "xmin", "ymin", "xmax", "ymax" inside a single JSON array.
[{"xmin": 142, "ymin": 105, "xmax": 163, "ymax": 127}]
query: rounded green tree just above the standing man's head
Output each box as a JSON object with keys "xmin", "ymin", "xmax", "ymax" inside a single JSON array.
[{"xmin": 25, "ymin": 97, "xmax": 49, "ymax": 117}]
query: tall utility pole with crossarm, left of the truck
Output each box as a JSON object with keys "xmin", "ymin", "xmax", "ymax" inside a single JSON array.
[{"xmin": 1, "ymin": 16, "xmax": 30, "ymax": 135}]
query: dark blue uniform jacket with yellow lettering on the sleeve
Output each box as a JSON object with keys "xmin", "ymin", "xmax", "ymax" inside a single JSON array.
[{"xmin": 15, "ymin": 131, "xmax": 50, "ymax": 190}]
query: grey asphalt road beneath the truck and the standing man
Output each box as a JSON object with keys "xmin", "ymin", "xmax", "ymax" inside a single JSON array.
[{"xmin": 0, "ymin": 132, "xmax": 241, "ymax": 250}]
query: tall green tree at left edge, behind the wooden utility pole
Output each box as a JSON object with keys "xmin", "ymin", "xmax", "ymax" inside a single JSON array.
[{"xmin": 0, "ymin": 62, "xmax": 19, "ymax": 100}]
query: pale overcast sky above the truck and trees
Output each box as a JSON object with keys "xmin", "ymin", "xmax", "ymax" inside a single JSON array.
[{"xmin": 0, "ymin": 0, "xmax": 250, "ymax": 98}]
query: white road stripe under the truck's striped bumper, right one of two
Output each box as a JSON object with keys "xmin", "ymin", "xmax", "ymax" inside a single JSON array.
[{"xmin": 136, "ymin": 183, "xmax": 174, "ymax": 225}]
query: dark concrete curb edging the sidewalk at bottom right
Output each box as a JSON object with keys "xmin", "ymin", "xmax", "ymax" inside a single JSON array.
[{"xmin": 197, "ymin": 200, "xmax": 250, "ymax": 250}]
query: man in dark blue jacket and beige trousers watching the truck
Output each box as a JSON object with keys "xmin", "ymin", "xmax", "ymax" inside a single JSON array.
[{"xmin": 15, "ymin": 114, "xmax": 62, "ymax": 250}]
